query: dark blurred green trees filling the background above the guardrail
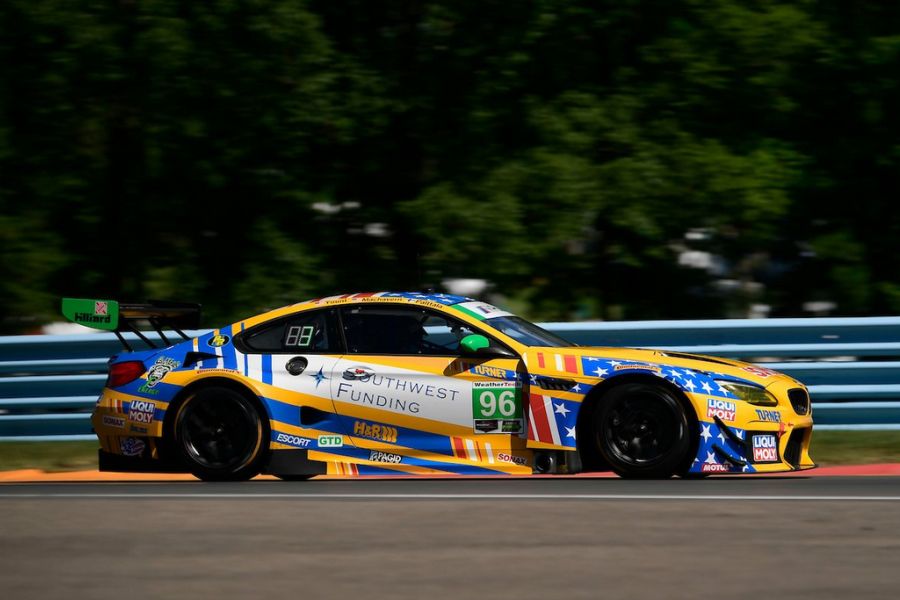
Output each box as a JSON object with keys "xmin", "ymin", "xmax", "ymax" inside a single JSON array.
[{"xmin": 0, "ymin": 0, "xmax": 900, "ymax": 333}]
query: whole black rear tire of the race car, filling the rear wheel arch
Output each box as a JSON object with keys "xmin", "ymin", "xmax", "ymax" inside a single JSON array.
[{"xmin": 173, "ymin": 386, "xmax": 269, "ymax": 481}]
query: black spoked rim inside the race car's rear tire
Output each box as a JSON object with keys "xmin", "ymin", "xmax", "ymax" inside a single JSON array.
[{"xmin": 181, "ymin": 395, "xmax": 259, "ymax": 470}]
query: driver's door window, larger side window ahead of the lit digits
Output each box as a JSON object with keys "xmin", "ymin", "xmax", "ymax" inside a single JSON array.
[{"xmin": 341, "ymin": 305, "xmax": 486, "ymax": 356}]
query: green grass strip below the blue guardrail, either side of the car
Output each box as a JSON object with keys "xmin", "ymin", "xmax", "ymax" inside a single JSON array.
[{"xmin": 0, "ymin": 431, "xmax": 900, "ymax": 471}]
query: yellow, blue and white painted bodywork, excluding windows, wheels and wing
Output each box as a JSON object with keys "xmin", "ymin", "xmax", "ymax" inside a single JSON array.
[{"xmin": 92, "ymin": 295, "xmax": 814, "ymax": 475}]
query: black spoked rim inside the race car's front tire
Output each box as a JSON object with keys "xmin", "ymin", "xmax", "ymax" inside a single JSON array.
[{"xmin": 601, "ymin": 392, "xmax": 681, "ymax": 467}]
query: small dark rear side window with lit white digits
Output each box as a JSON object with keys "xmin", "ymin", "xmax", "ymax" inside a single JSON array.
[{"xmin": 241, "ymin": 310, "xmax": 341, "ymax": 354}]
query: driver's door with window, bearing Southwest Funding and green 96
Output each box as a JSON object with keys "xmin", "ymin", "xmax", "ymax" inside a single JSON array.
[{"xmin": 332, "ymin": 304, "xmax": 525, "ymax": 471}]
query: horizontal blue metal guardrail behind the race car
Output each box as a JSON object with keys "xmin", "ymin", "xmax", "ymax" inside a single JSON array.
[{"xmin": 0, "ymin": 317, "xmax": 900, "ymax": 441}]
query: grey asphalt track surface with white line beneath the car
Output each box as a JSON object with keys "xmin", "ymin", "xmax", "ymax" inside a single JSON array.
[{"xmin": 0, "ymin": 476, "xmax": 900, "ymax": 599}]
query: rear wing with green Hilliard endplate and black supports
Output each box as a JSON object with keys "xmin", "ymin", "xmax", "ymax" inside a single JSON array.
[{"xmin": 62, "ymin": 298, "xmax": 200, "ymax": 352}]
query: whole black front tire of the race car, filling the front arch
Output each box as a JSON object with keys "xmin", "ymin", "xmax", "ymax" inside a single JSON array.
[{"xmin": 591, "ymin": 382, "xmax": 691, "ymax": 479}]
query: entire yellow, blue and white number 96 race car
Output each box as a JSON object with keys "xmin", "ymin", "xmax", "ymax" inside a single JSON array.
[{"xmin": 63, "ymin": 292, "xmax": 815, "ymax": 481}]
